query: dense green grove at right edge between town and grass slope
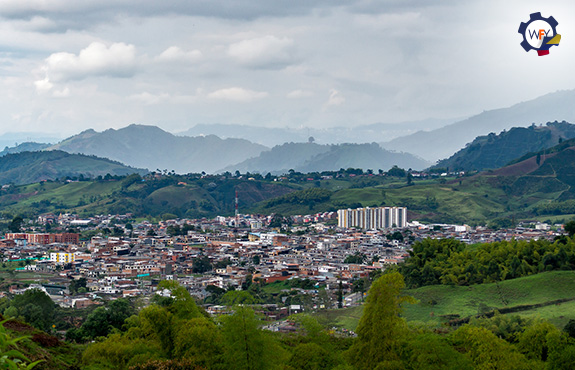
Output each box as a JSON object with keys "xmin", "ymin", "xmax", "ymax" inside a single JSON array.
[{"xmin": 400, "ymin": 239, "xmax": 575, "ymax": 287}]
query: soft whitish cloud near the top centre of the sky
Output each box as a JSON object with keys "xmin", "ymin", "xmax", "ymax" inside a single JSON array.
[{"xmin": 228, "ymin": 35, "xmax": 295, "ymax": 69}]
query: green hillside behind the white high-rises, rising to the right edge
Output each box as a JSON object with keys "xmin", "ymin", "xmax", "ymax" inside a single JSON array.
[{"xmin": 250, "ymin": 139, "xmax": 575, "ymax": 225}]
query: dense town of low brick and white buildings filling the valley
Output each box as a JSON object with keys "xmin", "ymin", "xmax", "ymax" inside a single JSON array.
[{"xmin": 0, "ymin": 209, "xmax": 563, "ymax": 318}]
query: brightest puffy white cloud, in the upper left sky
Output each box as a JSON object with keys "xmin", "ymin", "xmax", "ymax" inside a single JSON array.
[{"xmin": 44, "ymin": 42, "xmax": 136, "ymax": 81}]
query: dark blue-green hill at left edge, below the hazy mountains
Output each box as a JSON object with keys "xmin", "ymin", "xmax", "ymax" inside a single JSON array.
[{"xmin": 0, "ymin": 150, "xmax": 146, "ymax": 185}]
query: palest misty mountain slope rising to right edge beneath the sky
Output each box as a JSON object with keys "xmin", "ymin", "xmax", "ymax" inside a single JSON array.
[{"xmin": 381, "ymin": 90, "xmax": 575, "ymax": 162}]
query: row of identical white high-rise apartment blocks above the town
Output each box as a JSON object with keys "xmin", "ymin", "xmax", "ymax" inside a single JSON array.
[{"xmin": 337, "ymin": 207, "xmax": 407, "ymax": 230}]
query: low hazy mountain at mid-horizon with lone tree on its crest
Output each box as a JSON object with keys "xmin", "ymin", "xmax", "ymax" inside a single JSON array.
[{"xmin": 221, "ymin": 143, "xmax": 429, "ymax": 174}]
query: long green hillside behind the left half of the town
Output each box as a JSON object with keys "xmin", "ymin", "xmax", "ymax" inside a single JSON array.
[{"xmin": 0, "ymin": 175, "xmax": 294, "ymax": 218}]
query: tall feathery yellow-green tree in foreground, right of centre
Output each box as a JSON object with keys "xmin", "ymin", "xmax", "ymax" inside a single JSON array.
[{"xmin": 348, "ymin": 272, "xmax": 414, "ymax": 370}]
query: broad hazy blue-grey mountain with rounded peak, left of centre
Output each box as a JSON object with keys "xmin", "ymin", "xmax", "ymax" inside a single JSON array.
[{"xmin": 50, "ymin": 125, "xmax": 267, "ymax": 173}]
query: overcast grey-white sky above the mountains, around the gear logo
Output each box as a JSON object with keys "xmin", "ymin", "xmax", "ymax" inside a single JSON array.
[{"xmin": 0, "ymin": 0, "xmax": 575, "ymax": 137}]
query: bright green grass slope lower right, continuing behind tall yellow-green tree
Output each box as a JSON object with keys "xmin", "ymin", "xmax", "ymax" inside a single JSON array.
[{"xmin": 316, "ymin": 271, "xmax": 575, "ymax": 330}]
